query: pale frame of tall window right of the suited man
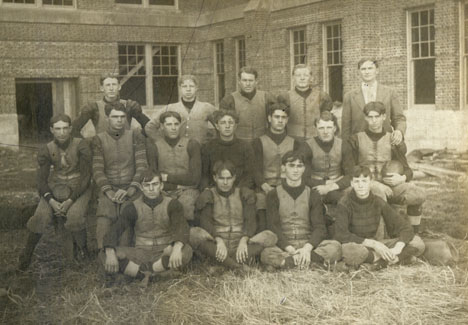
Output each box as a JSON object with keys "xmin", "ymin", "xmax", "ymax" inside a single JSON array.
[{"xmin": 406, "ymin": 5, "xmax": 437, "ymax": 109}]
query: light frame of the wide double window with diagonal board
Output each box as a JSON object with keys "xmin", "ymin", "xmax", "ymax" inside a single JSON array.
[{"xmin": 117, "ymin": 42, "xmax": 182, "ymax": 110}]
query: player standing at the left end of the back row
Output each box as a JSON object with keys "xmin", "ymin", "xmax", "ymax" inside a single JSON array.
[{"xmin": 73, "ymin": 73, "xmax": 149, "ymax": 137}]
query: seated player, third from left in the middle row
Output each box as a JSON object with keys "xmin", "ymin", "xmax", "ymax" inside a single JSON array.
[{"xmin": 147, "ymin": 111, "xmax": 201, "ymax": 222}]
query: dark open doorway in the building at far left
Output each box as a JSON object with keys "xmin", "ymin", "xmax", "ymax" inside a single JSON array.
[{"xmin": 16, "ymin": 82, "xmax": 53, "ymax": 144}]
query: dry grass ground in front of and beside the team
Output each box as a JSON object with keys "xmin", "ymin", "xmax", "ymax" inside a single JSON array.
[{"xmin": 0, "ymin": 147, "xmax": 468, "ymax": 324}]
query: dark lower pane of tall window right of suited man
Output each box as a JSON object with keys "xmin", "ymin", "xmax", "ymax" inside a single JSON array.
[{"xmin": 414, "ymin": 59, "xmax": 435, "ymax": 104}]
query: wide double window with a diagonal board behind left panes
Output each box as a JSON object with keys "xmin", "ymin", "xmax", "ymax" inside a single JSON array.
[{"xmin": 118, "ymin": 44, "xmax": 179, "ymax": 107}]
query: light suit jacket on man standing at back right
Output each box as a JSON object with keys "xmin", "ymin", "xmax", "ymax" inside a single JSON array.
[{"xmin": 341, "ymin": 83, "xmax": 406, "ymax": 140}]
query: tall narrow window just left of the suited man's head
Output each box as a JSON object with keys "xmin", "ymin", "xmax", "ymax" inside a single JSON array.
[{"xmin": 323, "ymin": 23, "xmax": 343, "ymax": 102}]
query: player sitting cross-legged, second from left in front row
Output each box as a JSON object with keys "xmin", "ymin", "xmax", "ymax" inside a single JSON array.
[{"xmin": 191, "ymin": 161, "xmax": 276, "ymax": 269}]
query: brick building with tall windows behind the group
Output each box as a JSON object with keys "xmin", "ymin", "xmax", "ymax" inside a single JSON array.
[{"xmin": 0, "ymin": 0, "xmax": 468, "ymax": 150}]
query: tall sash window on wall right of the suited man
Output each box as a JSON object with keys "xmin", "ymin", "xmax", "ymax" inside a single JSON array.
[{"xmin": 408, "ymin": 9, "xmax": 435, "ymax": 106}]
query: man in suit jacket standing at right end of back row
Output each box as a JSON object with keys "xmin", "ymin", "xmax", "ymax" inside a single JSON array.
[{"xmin": 341, "ymin": 58, "xmax": 406, "ymax": 145}]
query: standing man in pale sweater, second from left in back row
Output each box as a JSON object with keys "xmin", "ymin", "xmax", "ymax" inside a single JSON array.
[{"xmin": 145, "ymin": 75, "xmax": 215, "ymax": 145}]
